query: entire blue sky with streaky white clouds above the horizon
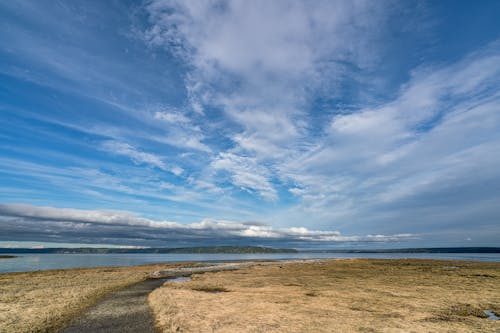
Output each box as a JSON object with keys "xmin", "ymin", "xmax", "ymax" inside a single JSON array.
[{"xmin": 0, "ymin": 0, "xmax": 500, "ymax": 249}]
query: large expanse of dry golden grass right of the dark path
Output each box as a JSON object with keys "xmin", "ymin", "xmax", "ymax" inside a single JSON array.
[{"xmin": 149, "ymin": 259, "xmax": 500, "ymax": 332}]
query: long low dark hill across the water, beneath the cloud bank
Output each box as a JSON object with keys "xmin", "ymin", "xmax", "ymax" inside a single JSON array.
[{"xmin": 0, "ymin": 246, "xmax": 298, "ymax": 254}]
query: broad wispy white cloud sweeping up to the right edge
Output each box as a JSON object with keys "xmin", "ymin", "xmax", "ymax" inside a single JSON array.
[{"xmin": 279, "ymin": 44, "xmax": 500, "ymax": 225}]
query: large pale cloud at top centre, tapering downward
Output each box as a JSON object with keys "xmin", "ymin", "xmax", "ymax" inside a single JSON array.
[{"xmin": 144, "ymin": 0, "xmax": 389, "ymax": 159}]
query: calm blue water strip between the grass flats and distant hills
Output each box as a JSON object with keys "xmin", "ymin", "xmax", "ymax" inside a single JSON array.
[{"xmin": 0, "ymin": 253, "xmax": 500, "ymax": 273}]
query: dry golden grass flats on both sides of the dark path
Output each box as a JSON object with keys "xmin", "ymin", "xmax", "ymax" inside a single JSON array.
[{"xmin": 0, "ymin": 259, "xmax": 500, "ymax": 332}]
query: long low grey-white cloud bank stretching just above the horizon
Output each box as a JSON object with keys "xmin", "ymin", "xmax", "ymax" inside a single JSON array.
[{"xmin": 0, "ymin": 204, "xmax": 416, "ymax": 246}]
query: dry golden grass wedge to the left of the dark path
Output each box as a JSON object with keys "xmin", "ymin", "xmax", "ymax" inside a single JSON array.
[{"xmin": 0, "ymin": 265, "xmax": 179, "ymax": 333}]
